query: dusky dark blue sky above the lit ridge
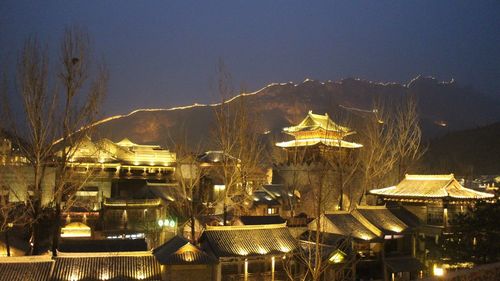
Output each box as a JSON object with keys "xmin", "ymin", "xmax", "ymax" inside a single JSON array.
[{"xmin": 0, "ymin": 0, "xmax": 500, "ymax": 115}]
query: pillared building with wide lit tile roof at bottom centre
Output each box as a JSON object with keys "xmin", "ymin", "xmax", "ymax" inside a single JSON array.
[{"xmin": 200, "ymin": 223, "xmax": 298, "ymax": 280}]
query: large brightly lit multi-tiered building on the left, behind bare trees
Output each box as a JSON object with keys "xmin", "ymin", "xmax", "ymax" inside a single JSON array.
[{"xmin": 58, "ymin": 138, "xmax": 176, "ymax": 246}]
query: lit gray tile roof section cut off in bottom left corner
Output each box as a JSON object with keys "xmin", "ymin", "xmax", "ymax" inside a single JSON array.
[{"xmin": 0, "ymin": 256, "xmax": 54, "ymax": 281}]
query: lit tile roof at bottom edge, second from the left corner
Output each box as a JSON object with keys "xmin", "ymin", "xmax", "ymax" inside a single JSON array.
[{"xmin": 52, "ymin": 252, "xmax": 161, "ymax": 281}]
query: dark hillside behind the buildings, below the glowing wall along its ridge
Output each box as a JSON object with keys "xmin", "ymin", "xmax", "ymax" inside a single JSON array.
[{"xmin": 93, "ymin": 77, "xmax": 500, "ymax": 148}]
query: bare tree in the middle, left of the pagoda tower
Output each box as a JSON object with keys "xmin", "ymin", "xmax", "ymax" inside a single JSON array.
[{"xmin": 214, "ymin": 62, "xmax": 264, "ymax": 224}]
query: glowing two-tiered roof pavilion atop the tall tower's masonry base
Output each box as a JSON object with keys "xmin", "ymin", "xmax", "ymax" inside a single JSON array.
[{"xmin": 276, "ymin": 111, "xmax": 362, "ymax": 163}]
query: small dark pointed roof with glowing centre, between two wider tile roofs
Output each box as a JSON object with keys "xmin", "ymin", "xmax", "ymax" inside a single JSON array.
[{"xmin": 153, "ymin": 236, "xmax": 218, "ymax": 265}]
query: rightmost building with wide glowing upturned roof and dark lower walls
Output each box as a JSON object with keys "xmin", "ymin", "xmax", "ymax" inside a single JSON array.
[{"xmin": 370, "ymin": 174, "xmax": 495, "ymax": 274}]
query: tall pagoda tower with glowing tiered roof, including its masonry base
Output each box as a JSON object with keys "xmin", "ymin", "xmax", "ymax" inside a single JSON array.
[{"xmin": 272, "ymin": 111, "xmax": 362, "ymax": 213}]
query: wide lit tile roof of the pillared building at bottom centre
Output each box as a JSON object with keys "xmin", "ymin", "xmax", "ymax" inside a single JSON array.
[{"xmin": 201, "ymin": 224, "xmax": 297, "ymax": 258}]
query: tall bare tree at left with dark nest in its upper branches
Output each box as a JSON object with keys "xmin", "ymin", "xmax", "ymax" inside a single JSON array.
[{"xmin": 52, "ymin": 27, "xmax": 108, "ymax": 255}]
